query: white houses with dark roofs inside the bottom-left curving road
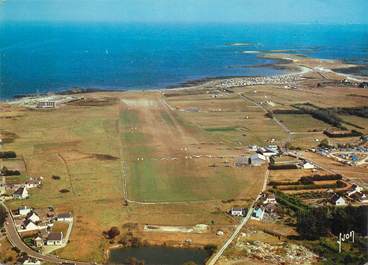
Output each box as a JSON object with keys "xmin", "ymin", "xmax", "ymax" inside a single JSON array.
[{"xmin": 12, "ymin": 206, "xmax": 73, "ymax": 248}]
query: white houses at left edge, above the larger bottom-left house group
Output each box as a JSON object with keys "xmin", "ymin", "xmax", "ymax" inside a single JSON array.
[{"xmin": 0, "ymin": 177, "xmax": 43, "ymax": 200}]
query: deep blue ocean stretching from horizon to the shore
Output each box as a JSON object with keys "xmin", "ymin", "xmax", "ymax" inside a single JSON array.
[{"xmin": 0, "ymin": 22, "xmax": 368, "ymax": 99}]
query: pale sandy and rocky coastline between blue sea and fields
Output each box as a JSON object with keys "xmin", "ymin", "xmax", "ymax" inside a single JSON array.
[{"xmin": 1, "ymin": 52, "xmax": 368, "ymax": 102}]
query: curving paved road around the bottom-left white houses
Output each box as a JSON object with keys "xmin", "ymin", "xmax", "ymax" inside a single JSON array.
[{"xmin": 1, "ymin": 203, "xmax": 92, "ymax": 265}]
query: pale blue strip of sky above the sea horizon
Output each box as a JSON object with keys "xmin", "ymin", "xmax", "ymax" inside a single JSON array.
[{"xmin": 0, "ymin": 0, "xmax": 368, "ymax": 24}]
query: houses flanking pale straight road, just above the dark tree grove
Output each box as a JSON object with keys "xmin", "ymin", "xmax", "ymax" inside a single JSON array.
[{"xmin": 230, "ymin": 193, "xmax": 277, "ymax": 221}]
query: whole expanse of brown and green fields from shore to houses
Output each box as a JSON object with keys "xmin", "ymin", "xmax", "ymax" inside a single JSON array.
[{"xmin": 0, "ymin": 62, "xmax": 368, "ymax": 262}]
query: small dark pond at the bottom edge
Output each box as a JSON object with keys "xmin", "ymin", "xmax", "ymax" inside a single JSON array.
[{"xmin": 109, "ymin": 247, "xmax": 209, "ymax": 265}]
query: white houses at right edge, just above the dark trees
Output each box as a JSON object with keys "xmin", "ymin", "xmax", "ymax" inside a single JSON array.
[{"xmin": 329, "ymin": 184, "xmax": 368, "ymax": 206}]
